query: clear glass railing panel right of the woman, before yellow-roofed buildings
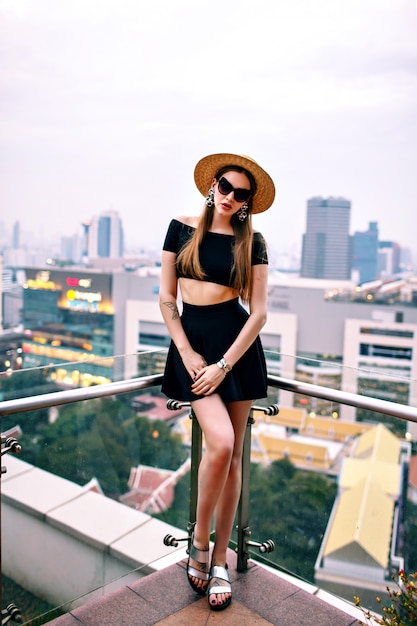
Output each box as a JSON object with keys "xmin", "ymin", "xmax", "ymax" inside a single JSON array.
[{"xmin": 250, "ymin": 355, "xmax": 417, "ymax": 610}]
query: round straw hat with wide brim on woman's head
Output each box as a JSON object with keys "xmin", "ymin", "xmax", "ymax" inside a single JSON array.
[{"xmin": 194, "ymin": 153, "xmax": 275, "ymax": 213}]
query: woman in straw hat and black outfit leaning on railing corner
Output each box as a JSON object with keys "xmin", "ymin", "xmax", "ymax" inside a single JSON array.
[{"xmin": 159, "ymin": 154, "xmax": 275, "ymax": 611}]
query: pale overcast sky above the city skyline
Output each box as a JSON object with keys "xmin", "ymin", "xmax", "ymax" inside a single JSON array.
[{"xmin": 0, "ymin": 0, "xmax": 417, "ymax": 254}]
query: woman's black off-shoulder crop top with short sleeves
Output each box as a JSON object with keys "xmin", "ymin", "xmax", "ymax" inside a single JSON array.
[{"xmin": 163, "ymin": 219, "xmax": 268, "ymax": 287}]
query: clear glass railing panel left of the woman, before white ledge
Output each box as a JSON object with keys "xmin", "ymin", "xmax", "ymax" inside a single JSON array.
[{"xmin": 0, "ymin": 354, "xmax": 190, "ymax": 623}]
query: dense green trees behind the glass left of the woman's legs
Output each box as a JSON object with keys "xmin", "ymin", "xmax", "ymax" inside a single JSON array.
[{"xmin": 24, "ymin": 398, "xmax": 187, "ymax": 498}]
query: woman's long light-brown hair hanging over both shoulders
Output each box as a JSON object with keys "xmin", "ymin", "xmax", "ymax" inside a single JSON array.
[{"xmin": 177, "ymin": 166, "xmax": 256, "ymax": 302}]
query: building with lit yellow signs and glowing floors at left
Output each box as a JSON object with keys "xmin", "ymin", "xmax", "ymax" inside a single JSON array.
[{"xmin": 21, "ymin": 267, "xmax": 117, "ymax": 386}]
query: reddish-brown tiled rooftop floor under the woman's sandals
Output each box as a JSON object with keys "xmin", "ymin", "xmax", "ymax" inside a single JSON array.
[{"xmin": 44, "ymin": 555, "xmax": 358, "ymax": 626}]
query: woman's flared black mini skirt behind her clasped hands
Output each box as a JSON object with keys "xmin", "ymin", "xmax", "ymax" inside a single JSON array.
[{"xmin": 162, "ymin": 298, "xmax": 267, "ymax": 402}]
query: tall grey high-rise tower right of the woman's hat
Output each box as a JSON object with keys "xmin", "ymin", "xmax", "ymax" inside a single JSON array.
[{"xmin": 301, "ymin": 197, "xmax": 352, "ymax": 280}]
